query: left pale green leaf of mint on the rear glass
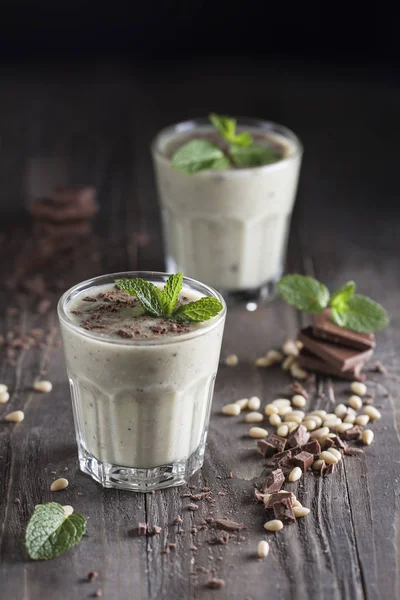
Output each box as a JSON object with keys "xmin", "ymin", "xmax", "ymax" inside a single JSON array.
[{"xmin": 171, "ymin": 140, "xmax": 226, "ymax": 174}]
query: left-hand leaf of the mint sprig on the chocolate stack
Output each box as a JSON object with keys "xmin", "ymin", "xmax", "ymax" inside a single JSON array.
[{"xmin": 278, "ymin": 274, "xmax": 329, "ymax": 313}]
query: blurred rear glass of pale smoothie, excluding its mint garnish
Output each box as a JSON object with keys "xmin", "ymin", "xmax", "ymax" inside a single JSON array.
[{"xmin": 152, "ymin": 118, "xmax": 303, "ymax": 306}]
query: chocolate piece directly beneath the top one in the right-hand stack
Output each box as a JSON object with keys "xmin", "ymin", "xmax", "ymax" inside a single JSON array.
[{"xmin": 297, "ymin": 327, "xmax": 373, "ymax": 371}]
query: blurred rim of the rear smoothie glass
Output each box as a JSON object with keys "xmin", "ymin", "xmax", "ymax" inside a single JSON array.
[{"xmin": 150, "ymin": 117, "xmax": 304, "ymax": 177}]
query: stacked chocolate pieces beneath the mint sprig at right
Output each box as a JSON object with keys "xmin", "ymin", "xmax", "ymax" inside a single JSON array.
[{"xmin": 297, "ymin": 309, "xmax": 375, "ymax": 381}]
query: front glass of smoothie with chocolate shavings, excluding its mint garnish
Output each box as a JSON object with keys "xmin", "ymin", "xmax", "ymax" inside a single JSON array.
[{"xmin": 58, "ymin": 272, "xmax": 226, "ymax": 492}]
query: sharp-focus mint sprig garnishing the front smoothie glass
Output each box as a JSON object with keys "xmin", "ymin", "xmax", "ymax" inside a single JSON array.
[{"xmin": 115, "ymin": 273, "xmax": 223, "ymax": 322}]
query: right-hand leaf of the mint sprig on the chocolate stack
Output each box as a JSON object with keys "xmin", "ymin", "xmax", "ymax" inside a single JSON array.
[{"xmin": 331, "ymin": 294, "xmax": 389, "ymax": 333}]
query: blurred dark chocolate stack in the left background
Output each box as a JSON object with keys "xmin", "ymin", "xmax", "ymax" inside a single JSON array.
[{"xmin": 27, "ymin": 186, "xmax": 98, "ymax": 240}]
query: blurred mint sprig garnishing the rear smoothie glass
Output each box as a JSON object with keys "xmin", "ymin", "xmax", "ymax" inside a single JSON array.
[{"xmin": 171, "ymin": 113, "xmax": 280, "ymax": 175}]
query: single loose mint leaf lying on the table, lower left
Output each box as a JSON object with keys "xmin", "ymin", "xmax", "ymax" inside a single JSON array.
[{"xmin": 25, "ymin": 502, "xmax": 86, "ymax": 560}]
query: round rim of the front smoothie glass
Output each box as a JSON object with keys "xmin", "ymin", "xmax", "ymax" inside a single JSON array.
[{"xmin": 57, "ymin": 271, "xmax": 227, "ymax": 347}]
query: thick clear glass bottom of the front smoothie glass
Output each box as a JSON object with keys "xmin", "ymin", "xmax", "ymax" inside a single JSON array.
[{"xmin": 78, "ymin": 436, "xmax": 205, "ymax": 492}]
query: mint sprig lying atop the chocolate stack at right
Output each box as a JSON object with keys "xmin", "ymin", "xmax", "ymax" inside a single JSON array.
[{"xmin": 278, "ymin": 274, "xmax": 389, "ymax": 333}]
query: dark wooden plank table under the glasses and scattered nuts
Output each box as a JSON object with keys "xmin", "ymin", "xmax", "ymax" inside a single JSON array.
[{"xmin": 0, "ymin": 62, "xmax": 400, "ymax": 600}]
